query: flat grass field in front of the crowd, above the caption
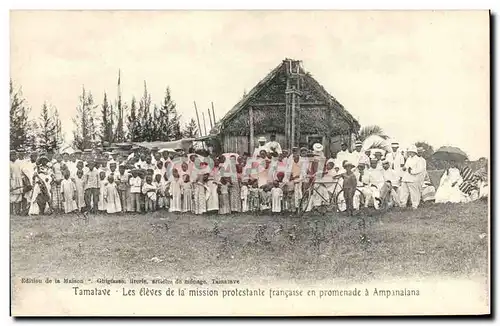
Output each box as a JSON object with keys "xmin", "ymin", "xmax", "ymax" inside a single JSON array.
[{"xmin": 11, "ymin": 202, "xmax": 489, "ymax": 281}]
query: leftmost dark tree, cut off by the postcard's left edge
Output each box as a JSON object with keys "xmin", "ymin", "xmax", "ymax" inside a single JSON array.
[{"xmin": 9, "ymin": 79, "xmax": 30, "ymax": 150}]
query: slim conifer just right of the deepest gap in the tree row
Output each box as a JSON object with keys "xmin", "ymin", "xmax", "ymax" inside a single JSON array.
[{"xmin": 73, "ymin": 88, "xmax": 96, "ymax": 150}]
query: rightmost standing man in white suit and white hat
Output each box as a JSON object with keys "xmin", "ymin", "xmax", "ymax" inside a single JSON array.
[{"xmin": 400, "ymin": 145, "xmax": 423, "ymax": 209}]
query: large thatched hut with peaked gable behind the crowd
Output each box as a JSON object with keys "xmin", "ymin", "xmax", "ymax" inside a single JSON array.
[{"xmin": 212, "ymin": 59, "xmax": 360, "ymax": 154}]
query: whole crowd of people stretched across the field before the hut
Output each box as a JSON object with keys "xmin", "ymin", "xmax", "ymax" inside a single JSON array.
[{"xmin": 10, "ymin": 136, "xmax": 488, "ymax": 215}]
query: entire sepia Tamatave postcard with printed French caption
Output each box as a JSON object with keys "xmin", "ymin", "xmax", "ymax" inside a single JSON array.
[{"xmin": 9, "ymin": 10, "xmax": 491, "ymax": 317}]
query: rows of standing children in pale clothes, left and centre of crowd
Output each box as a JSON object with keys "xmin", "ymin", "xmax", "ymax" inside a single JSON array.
[{"xmin": 15, "ymin": 146, "xmax": 318, "ymax": 215}]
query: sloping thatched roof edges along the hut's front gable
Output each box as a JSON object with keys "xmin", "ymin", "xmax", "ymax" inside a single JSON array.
[{"xmin": 210, "ymin": 59, "xmax": 360, "ymax": 134}]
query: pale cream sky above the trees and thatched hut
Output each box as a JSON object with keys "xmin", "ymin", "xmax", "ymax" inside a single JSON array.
[{"xmin": 10, "ymin": 11, "xmax": 490, "ymax": 159}]
